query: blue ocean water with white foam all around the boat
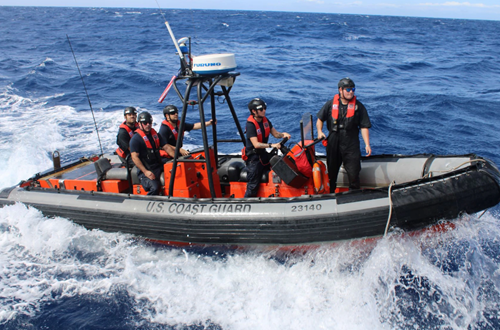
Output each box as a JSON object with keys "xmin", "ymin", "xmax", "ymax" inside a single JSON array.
[{"xmin": 0, "ymin": 7, "xmax": 500, "ymax": 329}]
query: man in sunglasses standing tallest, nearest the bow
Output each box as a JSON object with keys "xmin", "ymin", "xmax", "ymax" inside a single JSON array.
[{"xmin": 316, "ymin": 78, "xmax": 372, "ymax": 192}]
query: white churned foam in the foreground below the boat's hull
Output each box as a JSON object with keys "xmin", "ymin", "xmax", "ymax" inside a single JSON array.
[{"xmin": 0, "ymin": 204, "xmax": 500, "ymax": 329}]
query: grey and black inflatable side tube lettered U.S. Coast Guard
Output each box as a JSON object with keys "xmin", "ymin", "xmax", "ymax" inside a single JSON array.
[{"xmin": 0, "ymin": 154, "xmax": 500, "ymax": 245}]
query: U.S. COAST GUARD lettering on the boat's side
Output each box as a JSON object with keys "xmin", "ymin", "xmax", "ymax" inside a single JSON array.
[{"xmin": 146, "ymin": 202, "xmax": 252, "ymax": 214}]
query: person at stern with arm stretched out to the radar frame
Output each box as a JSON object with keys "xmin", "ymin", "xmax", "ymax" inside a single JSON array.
[{"xmin": 159, "ymin": 104, "xmax": 214, "ymax": 156}]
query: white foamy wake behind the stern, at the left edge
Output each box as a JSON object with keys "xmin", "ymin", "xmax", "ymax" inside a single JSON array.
[{"xmin": 0, "ymin": 87, "xmax": 119, "ymax": 188}]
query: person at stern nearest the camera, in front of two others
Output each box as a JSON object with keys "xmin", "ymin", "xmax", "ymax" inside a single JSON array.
[{"xmin": 130, "ymin": 111, "xmax": 174, "ymax": 195}]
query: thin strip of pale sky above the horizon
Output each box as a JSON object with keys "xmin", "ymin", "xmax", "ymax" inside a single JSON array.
[{"xmin": 0, "ymin": 0, "xmax": 500, "ymax": 21}]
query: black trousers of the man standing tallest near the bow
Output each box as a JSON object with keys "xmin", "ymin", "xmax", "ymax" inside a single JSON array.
[{"xmin": 326, "ymin": 134, "xmax": 361, "ymax": 193}]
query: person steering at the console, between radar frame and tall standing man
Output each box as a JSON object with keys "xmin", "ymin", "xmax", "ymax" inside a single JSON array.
[{"xmin": 245, "ymin": 98, "xmax": 290, "ymax": 197}]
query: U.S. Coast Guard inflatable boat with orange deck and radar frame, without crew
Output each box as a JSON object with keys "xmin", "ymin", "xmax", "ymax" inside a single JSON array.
[{"xmin": 0, "ymin": 39, "xmax": 500, "ymax": 246}]
